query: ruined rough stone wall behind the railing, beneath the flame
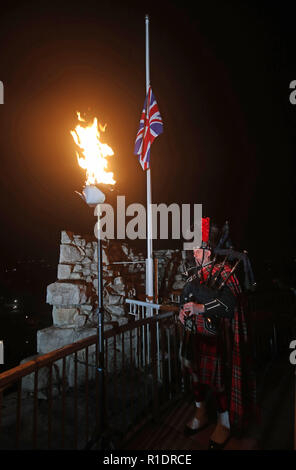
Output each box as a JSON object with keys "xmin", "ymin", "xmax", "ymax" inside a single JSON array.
[{"xmin": 22, "ymin": 231, "xmax": 184, "ymax": 395}]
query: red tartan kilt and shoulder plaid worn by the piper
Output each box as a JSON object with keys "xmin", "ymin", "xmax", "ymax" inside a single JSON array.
[{"xmin": 182, "ymin": 264, "xmax": 256, "ymax": 431}]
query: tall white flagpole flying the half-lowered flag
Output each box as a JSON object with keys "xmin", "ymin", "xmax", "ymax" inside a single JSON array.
[{"xmin": 145, "ymin": 15, "xmax": 153, "ymax": 302}]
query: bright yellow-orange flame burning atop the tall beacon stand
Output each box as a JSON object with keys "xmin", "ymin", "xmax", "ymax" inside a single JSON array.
[{"xmin": 70, "ymin": 112, "xmax": 116, "ymax": 186}]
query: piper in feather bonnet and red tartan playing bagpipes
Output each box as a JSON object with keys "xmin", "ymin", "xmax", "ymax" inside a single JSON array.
[{"xmin": 179, "ymin": 218, "xmax": 256, "ymax": 450}]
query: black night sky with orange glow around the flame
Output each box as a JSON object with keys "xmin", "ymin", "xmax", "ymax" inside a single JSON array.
[{"xmin": 0, "ymin": 0, "xmax": 296, "ymax": 278}]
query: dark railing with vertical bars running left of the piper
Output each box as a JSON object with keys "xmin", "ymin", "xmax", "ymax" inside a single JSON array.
[{"xmin": 0, "ymin": 308, "xmax": 182, "ymax": 449}]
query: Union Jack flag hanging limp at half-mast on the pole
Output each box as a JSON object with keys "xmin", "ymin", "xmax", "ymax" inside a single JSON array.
[{"xmin": 134, "ymin": 87, "xmax": 163, "ymax": 170}]
